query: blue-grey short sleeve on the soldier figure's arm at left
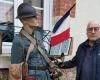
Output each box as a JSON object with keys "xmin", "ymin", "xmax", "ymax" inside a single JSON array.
[{"xmin": 11, "ymin": 36, "xmax": 23, "ymax": 64}]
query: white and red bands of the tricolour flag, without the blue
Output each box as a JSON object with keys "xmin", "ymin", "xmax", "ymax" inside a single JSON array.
[{"xmin": 51, "ymin": 17, "xmax": 70, "ymax": 46}]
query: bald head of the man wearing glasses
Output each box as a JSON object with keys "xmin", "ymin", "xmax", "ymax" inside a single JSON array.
[{"xmin": 87, "ymin": 21, "xmax": 100, "ymax": 41}]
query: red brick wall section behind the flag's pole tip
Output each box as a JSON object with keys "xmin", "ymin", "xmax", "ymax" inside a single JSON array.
[{"xmin": 53, "ymin": 0, "xmax": 76, "ymax": 17}]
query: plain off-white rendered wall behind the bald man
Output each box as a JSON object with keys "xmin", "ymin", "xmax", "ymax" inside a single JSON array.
[{"xmin": 71, "ymin": 0, "xmax": 100, "ymax": 57}]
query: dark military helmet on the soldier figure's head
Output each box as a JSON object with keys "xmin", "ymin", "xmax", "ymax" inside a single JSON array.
[{"xmin": 17, "ymin": 3, "xmax": 37, "ymax": 19}]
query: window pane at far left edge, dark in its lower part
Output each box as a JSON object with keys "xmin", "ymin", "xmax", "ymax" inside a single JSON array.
[{"xmin": 0, "ymin": 0, "xmax": 14, "ymax": 42}]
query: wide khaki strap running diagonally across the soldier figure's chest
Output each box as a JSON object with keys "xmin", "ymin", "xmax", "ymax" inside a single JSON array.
[{"xmin": 21, "ymin": 30, "xmax": 62, "ymax": 76}]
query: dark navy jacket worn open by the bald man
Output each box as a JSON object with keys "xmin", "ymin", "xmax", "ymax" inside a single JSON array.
[{"xmin": 63, "ymin": 39, "xmax": 100, "ymax": 80}]
